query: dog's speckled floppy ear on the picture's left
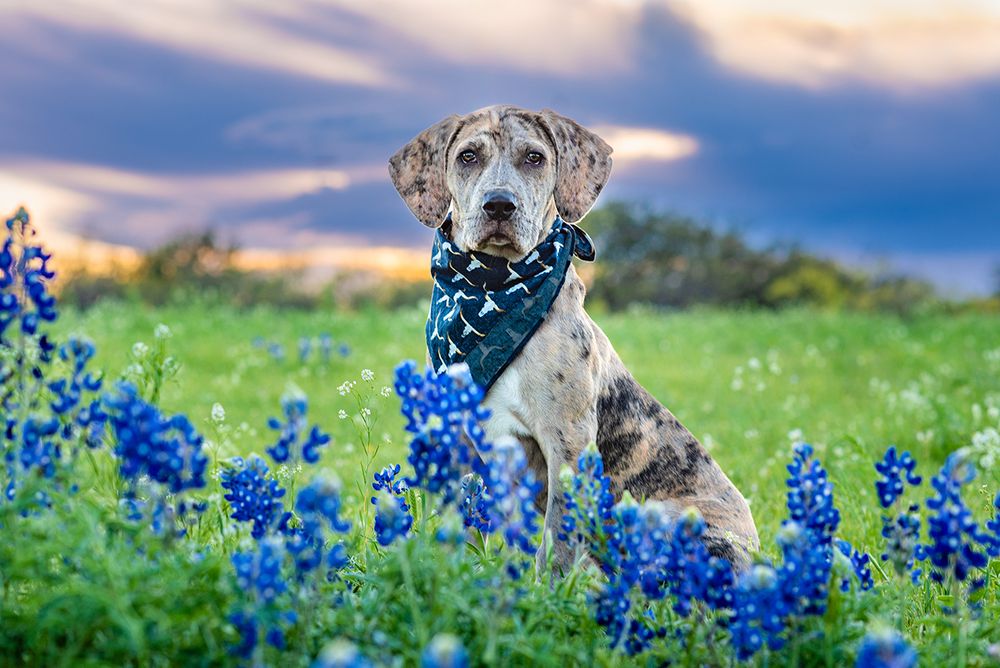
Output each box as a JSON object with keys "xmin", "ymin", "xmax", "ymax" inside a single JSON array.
[{"xmin": 389, "ymin": 116, "xmax": 461, "ymax": 227}]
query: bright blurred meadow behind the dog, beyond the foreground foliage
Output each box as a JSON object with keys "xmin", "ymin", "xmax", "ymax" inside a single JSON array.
[{"xmin": 59, "ymin": 303, "xmax": 1000, "ymax": 551}]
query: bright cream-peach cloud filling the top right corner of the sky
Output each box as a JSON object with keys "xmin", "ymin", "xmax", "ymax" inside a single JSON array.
[{"xmin": 670, "ymin": 0, "xmax": 1000, "ymax": 90}]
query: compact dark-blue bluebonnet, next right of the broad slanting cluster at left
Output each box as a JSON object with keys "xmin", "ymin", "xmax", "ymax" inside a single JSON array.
[{"xmin": 220, "ymin": 455, "xmax": 287, "ymax": 539}]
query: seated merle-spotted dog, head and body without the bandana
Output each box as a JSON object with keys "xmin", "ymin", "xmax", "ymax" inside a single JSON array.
[{"xmin": 389, "ymin": 105, "xmax": 759, "ymax": 572}]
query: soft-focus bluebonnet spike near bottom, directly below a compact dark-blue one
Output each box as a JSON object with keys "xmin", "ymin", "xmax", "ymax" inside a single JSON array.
[{"xmin": 229, "ymin": 538, "xmax": 295, "ymax": 658}]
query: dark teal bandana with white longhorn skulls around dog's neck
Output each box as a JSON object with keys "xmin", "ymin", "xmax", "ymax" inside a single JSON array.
[{"xmin": 427, "ymin": 218, "xmax": 595, "ymax": 390}]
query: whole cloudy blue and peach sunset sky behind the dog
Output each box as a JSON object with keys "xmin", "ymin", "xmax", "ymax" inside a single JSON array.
[{"xmin": 0, "ymin": 0, "xmax": 1000, "ymax": 294}]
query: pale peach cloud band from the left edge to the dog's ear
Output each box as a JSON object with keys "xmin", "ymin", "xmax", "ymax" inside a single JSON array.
[{"xmin": 0, "ymin": 158, "xmax": 387, "ymax": 246}]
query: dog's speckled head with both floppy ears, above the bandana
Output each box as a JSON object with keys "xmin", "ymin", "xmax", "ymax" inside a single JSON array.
[{"xmin": 389, "ymin": 106, "xmax": 611, "ymax": 260}]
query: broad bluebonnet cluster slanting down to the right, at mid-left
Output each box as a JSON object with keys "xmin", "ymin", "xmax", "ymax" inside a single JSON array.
[{"xmin": 104, "ymin": 383, "xmax": 208, "ymax": 494}]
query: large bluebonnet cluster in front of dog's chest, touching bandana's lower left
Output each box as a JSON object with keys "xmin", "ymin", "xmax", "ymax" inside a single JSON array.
[{"xmin": 394, "ymin": 361, "xmax": 489, "ymax": 504}]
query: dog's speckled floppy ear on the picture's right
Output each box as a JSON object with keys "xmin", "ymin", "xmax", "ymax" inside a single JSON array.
[{"xmin": 541, "ymin": 109, "xmax": 612, "ymax": 223}]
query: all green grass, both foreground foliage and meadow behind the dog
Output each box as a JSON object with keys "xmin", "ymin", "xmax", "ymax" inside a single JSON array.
[{"xmin": 25, "ymin": 301, "xmax": 1000, "ymax": 666}]
